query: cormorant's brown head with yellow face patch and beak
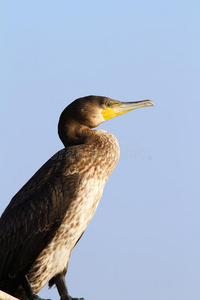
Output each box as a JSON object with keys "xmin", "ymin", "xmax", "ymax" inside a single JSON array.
[{"xmin": 58, "ymin": 96, "xmax": 154, "ymax": 144}]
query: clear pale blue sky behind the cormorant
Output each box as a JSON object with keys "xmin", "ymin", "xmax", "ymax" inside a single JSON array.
[{"xmin": 0, "ymin": 0, "xmax": 200, "ymax": 300}]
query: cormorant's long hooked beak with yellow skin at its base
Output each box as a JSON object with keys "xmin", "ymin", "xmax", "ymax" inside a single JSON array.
[{"xmin": 101, "ymin": 100, "xmax": 154, "ymax": 121}]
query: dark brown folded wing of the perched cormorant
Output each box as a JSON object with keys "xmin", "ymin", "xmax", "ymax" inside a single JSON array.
[{"xmin": 0, "ymin": 150, "xmax": 80, "ymax": 291}]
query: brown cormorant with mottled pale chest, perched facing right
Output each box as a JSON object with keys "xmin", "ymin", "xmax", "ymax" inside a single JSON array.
[{"xmin": 0, "ymin": 95, "xmax": 154, "ymax": 300}]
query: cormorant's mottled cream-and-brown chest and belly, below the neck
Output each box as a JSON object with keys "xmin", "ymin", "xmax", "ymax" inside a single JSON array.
[{"xmin": 29, "ymin": 135, "xmax": 119, "ymax": 292}]
